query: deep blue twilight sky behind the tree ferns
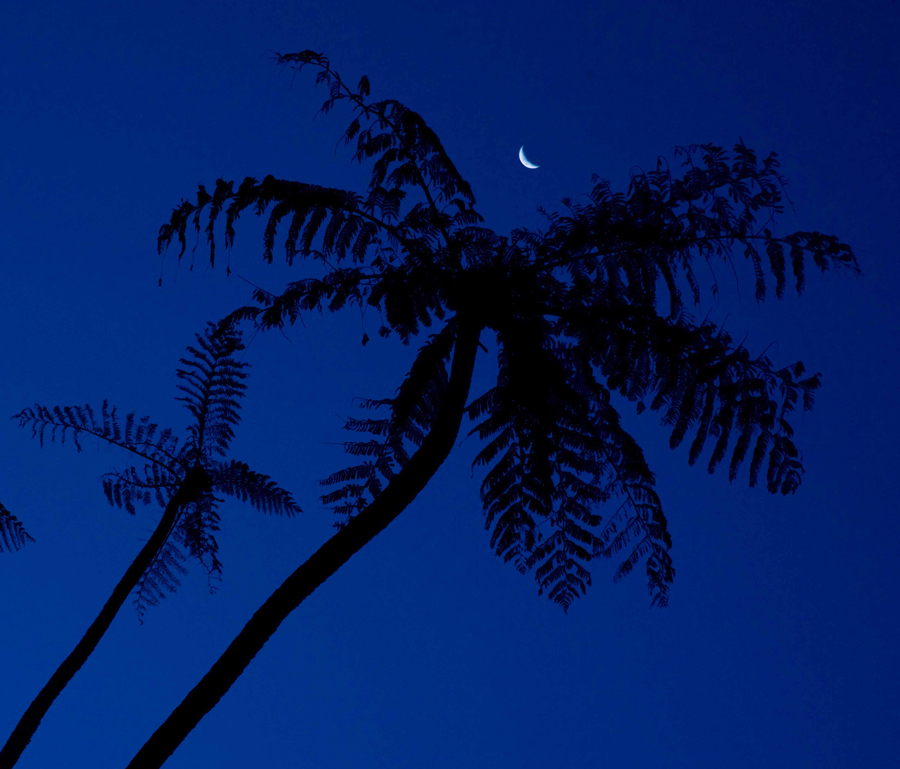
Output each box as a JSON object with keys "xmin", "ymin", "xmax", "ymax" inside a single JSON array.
[{"xmin": 0, "ymin": 0, "xmax": 900, "ymax": 769}]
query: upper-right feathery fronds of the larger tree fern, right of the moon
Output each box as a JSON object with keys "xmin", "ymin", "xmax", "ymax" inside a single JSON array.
[{"xmin": 529, "ymin": 143, "xmax": 859, "ymax": 317}]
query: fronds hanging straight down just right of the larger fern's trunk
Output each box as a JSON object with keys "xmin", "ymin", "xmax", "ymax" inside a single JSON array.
[{"xmin": 469, "ymin": 312, "xmax": 674, "ymax": 610}]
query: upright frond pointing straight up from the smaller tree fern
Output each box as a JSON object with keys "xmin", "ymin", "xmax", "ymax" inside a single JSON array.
[{"xmin": 178, "ymin": 323, "xmax": 248, "ymax": 461}]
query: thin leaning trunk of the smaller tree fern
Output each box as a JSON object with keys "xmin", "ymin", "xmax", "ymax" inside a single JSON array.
[{"xmin": 0, "ymin": 467, "xmax": 206, "ymax": 769}]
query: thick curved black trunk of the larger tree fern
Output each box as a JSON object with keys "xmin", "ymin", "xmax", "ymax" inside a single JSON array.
[{"xmin": 128, "ymin": 323, "xmax": 480, "ymax": 769}]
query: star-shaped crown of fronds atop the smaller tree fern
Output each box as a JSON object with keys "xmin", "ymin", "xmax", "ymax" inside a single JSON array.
[{"xmin": 13, "ymin": 323, "xmax": 300, "ymax": 615}]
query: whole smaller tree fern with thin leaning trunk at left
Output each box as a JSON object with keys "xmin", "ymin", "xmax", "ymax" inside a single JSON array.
[{"xmin": 0, "ymin": 323, "xmax": 300, "ymax": 769}]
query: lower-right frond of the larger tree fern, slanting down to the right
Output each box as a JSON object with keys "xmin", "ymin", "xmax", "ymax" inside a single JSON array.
[{"xmin": 566, "ymin": 307, "xmax": 820, "ymax": 494}]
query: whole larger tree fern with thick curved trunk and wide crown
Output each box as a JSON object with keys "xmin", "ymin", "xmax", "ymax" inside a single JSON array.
[{"xmin": 129, "ymin": 51, "xmax": 858, "ymax": 769}]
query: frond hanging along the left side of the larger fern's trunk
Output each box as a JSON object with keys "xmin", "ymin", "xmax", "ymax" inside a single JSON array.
[{"xmin": 321, "ymin": 322, "xmax": 456, "ymax": 526}]
